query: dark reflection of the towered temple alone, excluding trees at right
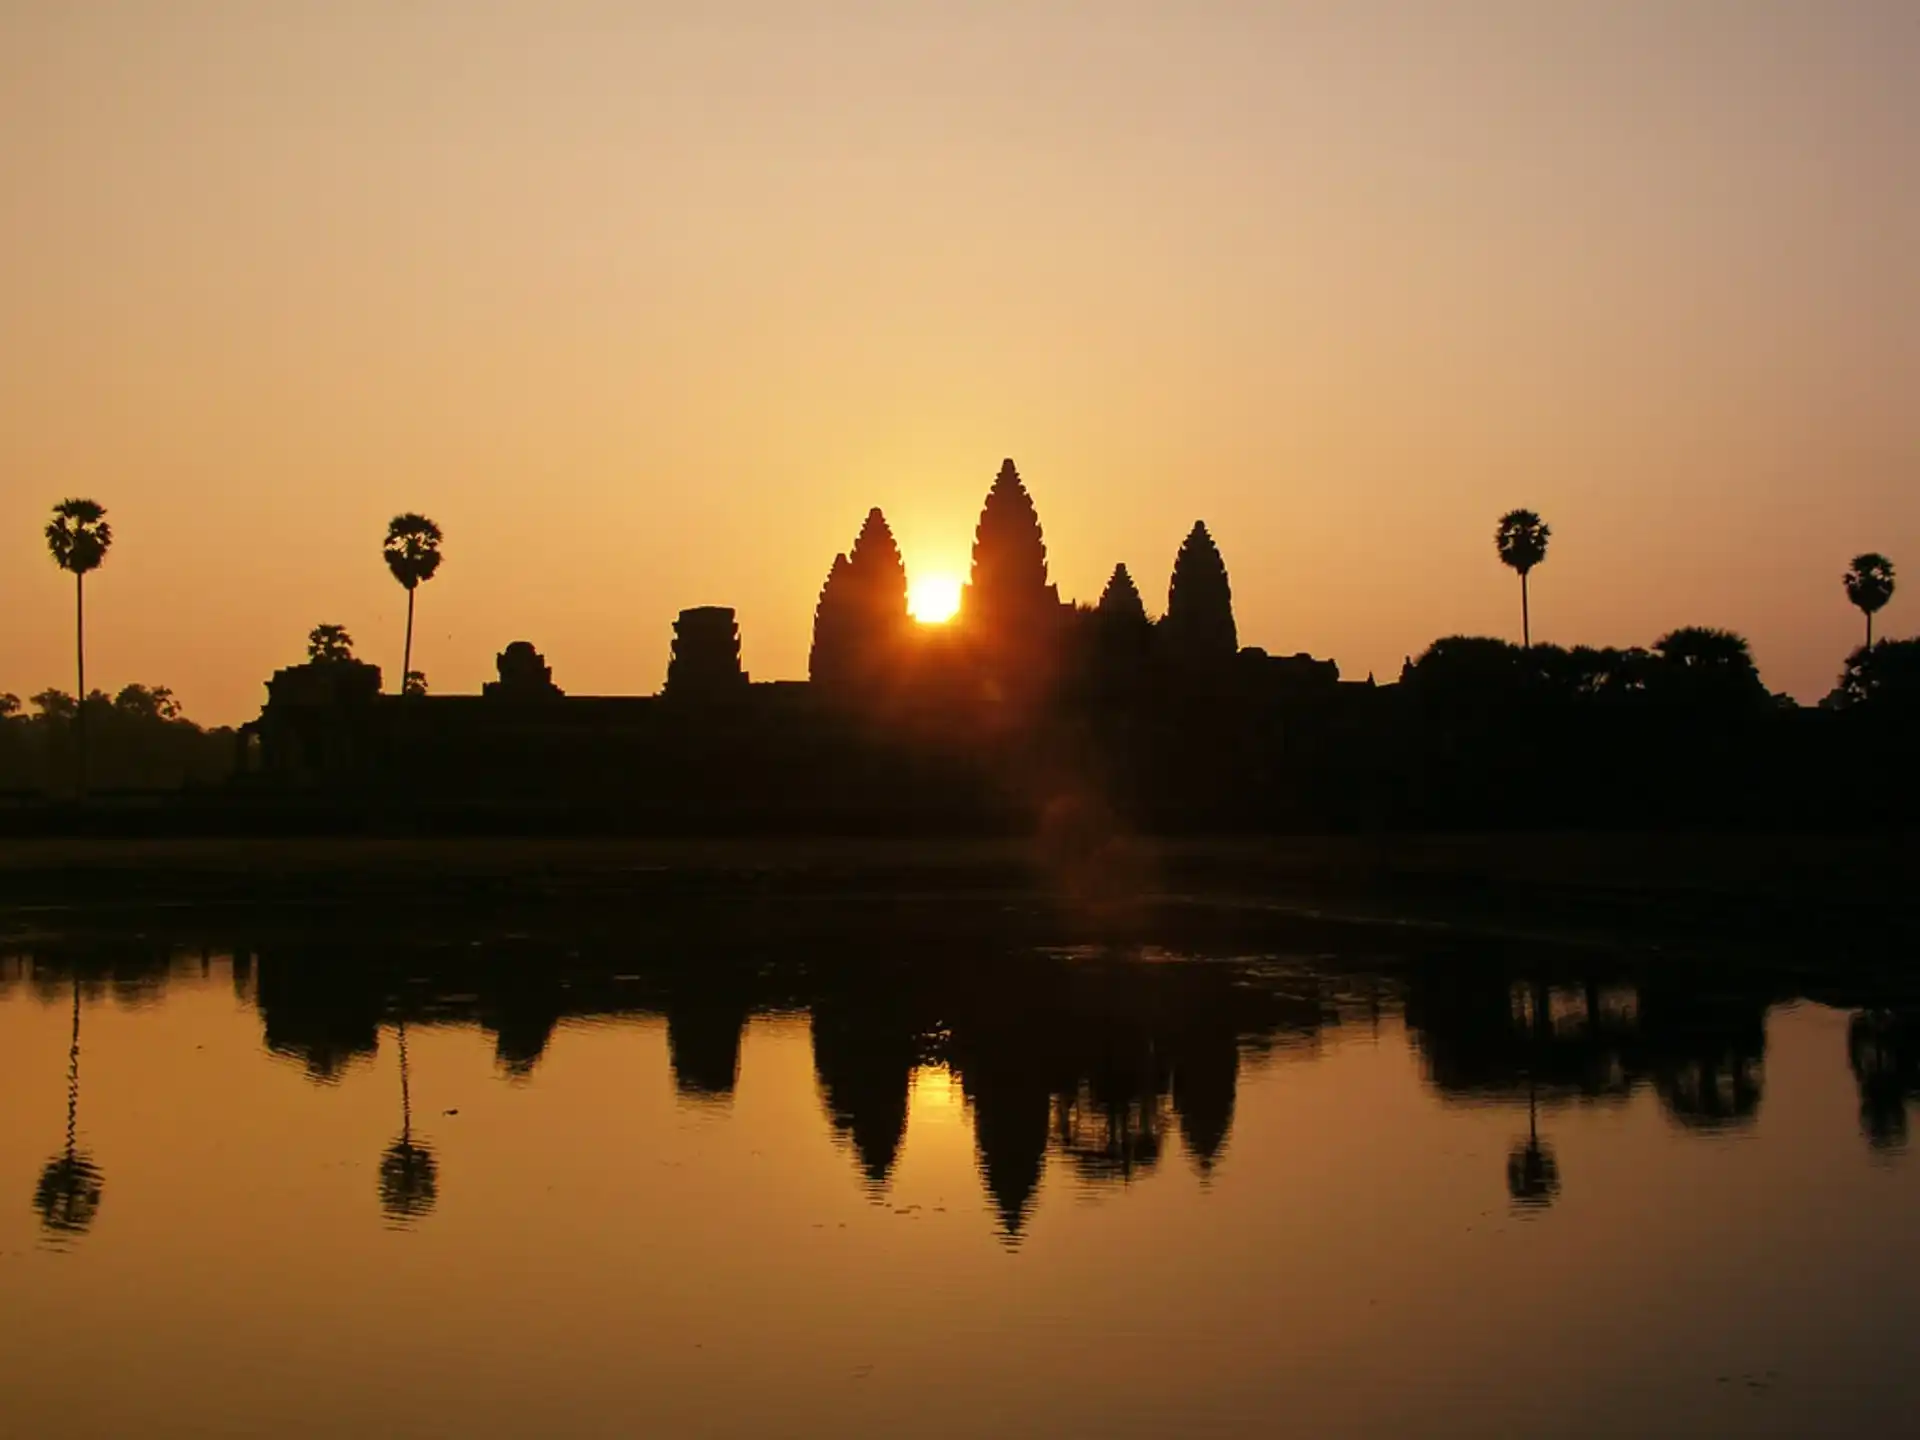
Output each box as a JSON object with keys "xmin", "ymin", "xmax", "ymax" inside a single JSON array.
[{"xmin": 0, "ymin": 943, "xmax": 1340, "ymax": 1236}]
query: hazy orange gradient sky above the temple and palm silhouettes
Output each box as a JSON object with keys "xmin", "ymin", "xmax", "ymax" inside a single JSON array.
[{"xmin": 0, "ymin": 0, "xmax": 1920, "ymax": 722}]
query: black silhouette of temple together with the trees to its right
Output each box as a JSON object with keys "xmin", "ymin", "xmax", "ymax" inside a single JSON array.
[{"xmin": 221, "ymin": 461, "xmax": 1920, "ymax": 829}]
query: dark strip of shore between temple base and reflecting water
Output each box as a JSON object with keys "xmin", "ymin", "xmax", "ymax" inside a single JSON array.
[{"xmin": 0, "ymin": 833, "xmax": 1920, "ymax": 975}]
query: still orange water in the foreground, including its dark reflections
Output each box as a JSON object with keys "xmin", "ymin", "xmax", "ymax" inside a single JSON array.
[{"xmin": 0, "ymin": 925, "xmax": 1920, "ymax": 1436}]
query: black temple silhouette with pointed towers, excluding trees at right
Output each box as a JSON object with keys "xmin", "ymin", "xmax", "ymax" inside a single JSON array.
[{"xmin": 238, "ymin": 461, "xmax": 1371, "ymax": 829}]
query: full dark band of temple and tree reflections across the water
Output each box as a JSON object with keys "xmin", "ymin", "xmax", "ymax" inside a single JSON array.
[{"xmin": 15, "ymin": 941, "xmax": 1920, "ymax": 1240}]
